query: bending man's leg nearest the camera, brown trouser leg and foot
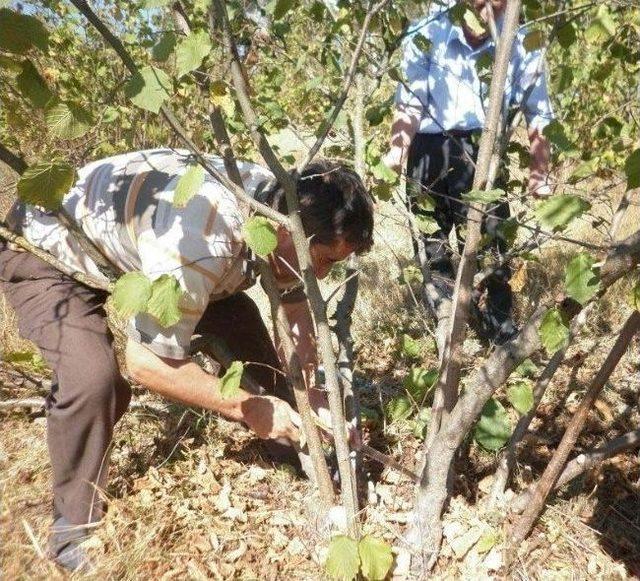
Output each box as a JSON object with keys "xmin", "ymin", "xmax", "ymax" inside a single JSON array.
[{"xmin": 0, "ymin": 249, "xmax": 131, "ymax": 568}]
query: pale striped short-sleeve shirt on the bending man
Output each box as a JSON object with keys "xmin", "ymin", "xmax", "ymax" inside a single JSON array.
[{"xmin": 9, "ymin": 149, "xmax": 272, "ymax": 359}]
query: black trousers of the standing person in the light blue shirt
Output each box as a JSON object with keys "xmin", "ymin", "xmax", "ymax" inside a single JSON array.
[{"xmin": 407, "ymin": 132, "xmax": 513, "ymax": 339}]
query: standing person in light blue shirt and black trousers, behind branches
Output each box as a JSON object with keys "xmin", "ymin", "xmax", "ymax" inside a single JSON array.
[{"xmin": 385, "ymin": 0, "xmax": 553, "ymax": 343}]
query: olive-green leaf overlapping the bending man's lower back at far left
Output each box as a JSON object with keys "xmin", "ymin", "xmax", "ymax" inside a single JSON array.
[{"xmin": 18, "ymin": 161, "xmax": 76, "ymax": 210}]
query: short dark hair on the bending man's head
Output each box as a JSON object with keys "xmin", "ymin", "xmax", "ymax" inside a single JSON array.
[{"xmin": 256, "ymin": 159, "xmax": 373, "ymax": 254}]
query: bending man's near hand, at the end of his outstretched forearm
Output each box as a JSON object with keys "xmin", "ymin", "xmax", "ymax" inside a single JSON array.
[{"xmin": 242, "ymin": 395, "xmax": 301, "ymax": 442}]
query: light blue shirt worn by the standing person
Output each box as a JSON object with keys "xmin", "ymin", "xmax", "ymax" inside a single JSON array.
[{"xmin": 396, "ymin": 11, "xmax": 553, "ymax": 133}]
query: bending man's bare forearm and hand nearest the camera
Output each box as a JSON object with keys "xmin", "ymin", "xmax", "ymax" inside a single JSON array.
[{"xmin": 125, "ymin": 339, "xmax": 299, "ymax": 441}]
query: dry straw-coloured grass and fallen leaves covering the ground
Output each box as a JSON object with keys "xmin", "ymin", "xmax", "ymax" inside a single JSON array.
[{"xmin": 0, "ymin": 169, "xmax": 640, "ymax": 579}]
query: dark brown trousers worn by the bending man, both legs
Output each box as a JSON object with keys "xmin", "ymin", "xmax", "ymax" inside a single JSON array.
[{"xmin": 0, "ymin": 242, "xmax": 291, "ymax": 525}]
